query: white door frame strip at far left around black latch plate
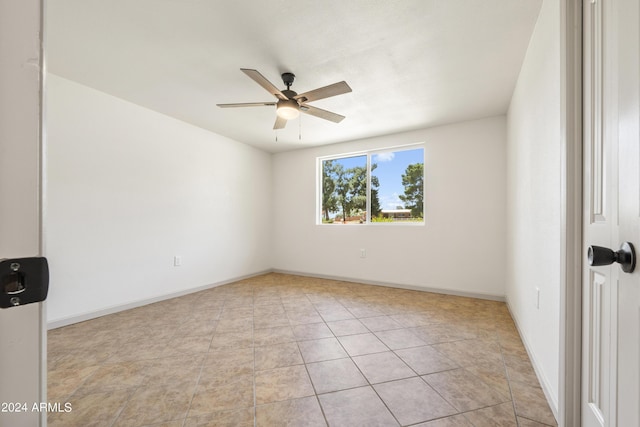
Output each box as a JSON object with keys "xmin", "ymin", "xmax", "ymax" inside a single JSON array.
[{"xmin": 0, "ymin": 0, "xmax": 46, "ymax": 427}]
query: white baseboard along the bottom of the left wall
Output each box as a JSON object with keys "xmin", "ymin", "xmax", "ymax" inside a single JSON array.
[{"xmin": 47, "ymin": 270, "xmax": 271, "ymax": 330}]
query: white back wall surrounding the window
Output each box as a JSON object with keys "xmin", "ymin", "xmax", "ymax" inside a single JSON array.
[{"xmin": 273, "ymin": 116, "xmax": 506, "ymax": 297}]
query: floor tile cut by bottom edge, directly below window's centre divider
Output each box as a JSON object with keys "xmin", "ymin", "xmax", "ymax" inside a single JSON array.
[{"xmin": 318, "ymin": 387, "xmax": 399, "ymax": 427}]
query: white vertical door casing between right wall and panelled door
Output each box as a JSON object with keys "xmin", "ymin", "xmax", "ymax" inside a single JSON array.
[{"xmin": 556, "ymin": 1, "xmax": 583, "ymax": 426}]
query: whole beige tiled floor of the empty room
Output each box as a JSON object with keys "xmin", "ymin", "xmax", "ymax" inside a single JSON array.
[{"xmin": 48, "ymin": 274, "xmax": 556, "ymax": 427}]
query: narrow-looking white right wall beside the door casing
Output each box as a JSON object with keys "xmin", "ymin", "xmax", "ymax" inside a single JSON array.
[{"xmin": 506, "ymin": 0, "xmax": 561, "ymax": 414}]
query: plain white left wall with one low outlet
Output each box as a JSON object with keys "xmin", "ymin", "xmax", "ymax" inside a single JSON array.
[{"xmin": 44, "ymin": 74, "xmax": 271, "ymax": 324}]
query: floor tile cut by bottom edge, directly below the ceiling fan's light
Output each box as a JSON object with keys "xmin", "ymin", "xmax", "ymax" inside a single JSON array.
[{"xmin": 256, "ymin": 396, "xmax": 327, "ymax": 427}]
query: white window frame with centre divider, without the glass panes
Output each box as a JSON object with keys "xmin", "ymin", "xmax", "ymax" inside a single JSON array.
[{"xmin": 316, "ymin": 142, "xmax": 426, "ymax": 227}]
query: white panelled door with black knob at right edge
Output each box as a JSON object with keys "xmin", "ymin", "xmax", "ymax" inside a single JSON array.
[{"xmin": 581, "ymin": 0, "xmax": 640, "ymax": 427}]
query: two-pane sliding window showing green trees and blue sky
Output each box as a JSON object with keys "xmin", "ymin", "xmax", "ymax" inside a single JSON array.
[{"xmin": 318, "ymin": 148, "xmax": 424, "ymax": 224}]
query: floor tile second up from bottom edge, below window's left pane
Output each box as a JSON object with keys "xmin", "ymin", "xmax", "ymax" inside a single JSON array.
[{"xmin": 307, "ymin": 359, "xmax": 367, "ymax": 394}]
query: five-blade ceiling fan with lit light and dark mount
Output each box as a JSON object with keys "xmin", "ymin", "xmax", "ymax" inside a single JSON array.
[{"xmin": 217, "ymin": 68, "xmax": 351, "ymax": 129}]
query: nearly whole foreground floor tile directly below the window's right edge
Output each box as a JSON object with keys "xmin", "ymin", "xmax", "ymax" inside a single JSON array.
[{"xmin": 373, "ymin": 377, "xmax": 458, "ymax": 425}]
